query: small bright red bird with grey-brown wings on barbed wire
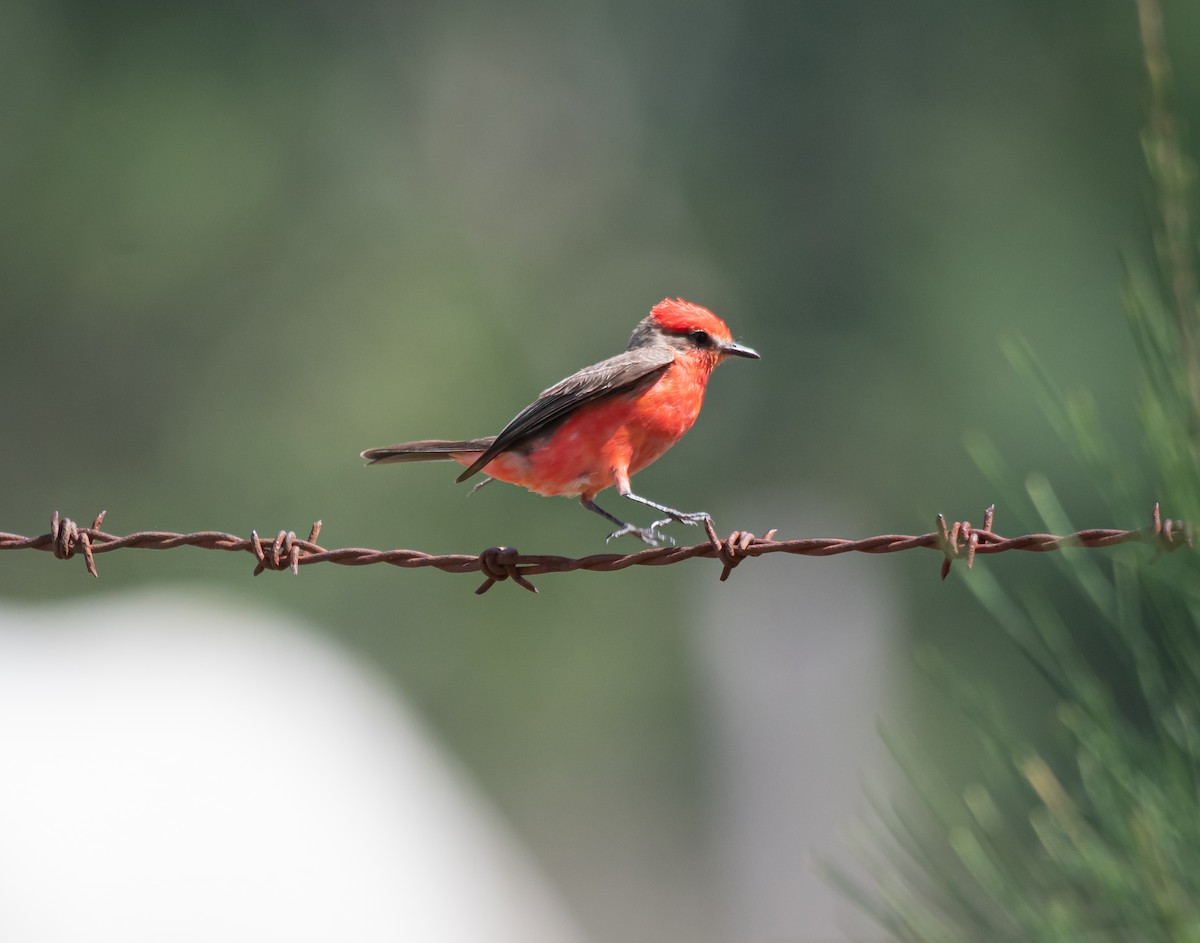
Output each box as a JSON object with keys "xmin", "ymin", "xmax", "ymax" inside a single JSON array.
[{"xmin": 362, "ymin": 298, "xmax": 758, "ymax": 546}]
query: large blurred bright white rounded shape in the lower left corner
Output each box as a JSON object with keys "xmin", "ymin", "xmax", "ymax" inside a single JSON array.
[{"xmin": 0, "ymin": 594, "xmax": 581, "ymax": 943}]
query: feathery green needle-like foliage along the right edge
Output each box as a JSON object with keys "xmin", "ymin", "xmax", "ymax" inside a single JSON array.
[{"xmin": 834, "ymin": 0, "xmax": 1200, "ymax": 943}]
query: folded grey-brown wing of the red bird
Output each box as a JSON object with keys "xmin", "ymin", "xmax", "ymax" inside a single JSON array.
[{"xmin": 456, "ymin": 347, "xmax": 674, "ymax": 481}]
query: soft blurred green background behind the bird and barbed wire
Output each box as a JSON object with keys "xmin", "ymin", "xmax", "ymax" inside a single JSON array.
[{"xmin": 0, "ymin": 0, "xmax": 1200, "ymax": 938}]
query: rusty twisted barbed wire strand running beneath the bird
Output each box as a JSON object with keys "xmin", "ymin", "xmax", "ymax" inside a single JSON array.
[{"xmin": 0, "ymin": 504, "xmax": 1193, "ymax": 594}]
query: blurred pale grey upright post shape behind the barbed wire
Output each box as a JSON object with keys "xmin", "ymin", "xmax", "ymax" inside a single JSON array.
[{"xmin": 697, "ymin": 494, "xmax": 901, "ymax": 943}]
